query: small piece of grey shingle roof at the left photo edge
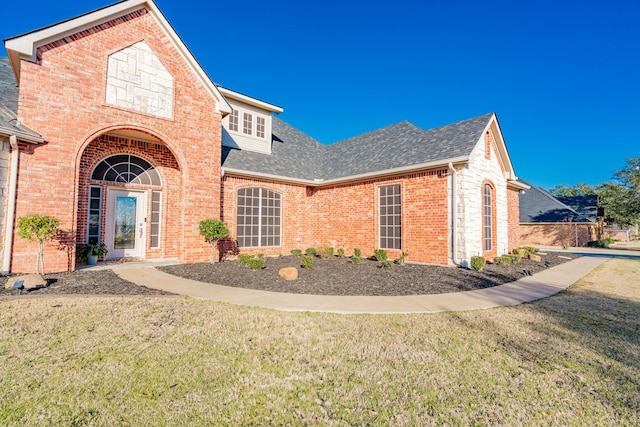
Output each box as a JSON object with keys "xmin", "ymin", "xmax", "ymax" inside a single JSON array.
[{"xmin": 0, "ymin": 56, "xmax": 42, "ymax": 142}]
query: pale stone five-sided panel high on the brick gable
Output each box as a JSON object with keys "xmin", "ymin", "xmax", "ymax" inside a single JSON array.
[{"xmin": 106, "ymin": 41, "xmax": 173, "ymax": 119}]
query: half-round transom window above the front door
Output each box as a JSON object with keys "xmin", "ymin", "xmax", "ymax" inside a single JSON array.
[{"xmin": 91, "ymin": 154, "xmax": 162, "ymax": 186}]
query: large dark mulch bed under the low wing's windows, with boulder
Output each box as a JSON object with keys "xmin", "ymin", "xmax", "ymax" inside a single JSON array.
[{"xmin": 160, "ymin": 253, "xmax": 577, "ymax": 295}]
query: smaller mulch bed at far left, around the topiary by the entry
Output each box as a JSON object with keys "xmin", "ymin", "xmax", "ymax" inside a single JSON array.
[{"xmin": 0, "ymin": 270, "xmax": 173, "ymax": 297}]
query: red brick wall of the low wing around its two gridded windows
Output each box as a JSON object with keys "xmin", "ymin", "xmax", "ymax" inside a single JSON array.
[{"xmin": 222, "ymin": 170, "xmax": 449, "ymax": 264}]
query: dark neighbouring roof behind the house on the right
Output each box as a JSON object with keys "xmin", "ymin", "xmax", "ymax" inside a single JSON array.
[{"xmin": 518, "ymin": 179, "xmax": 595, "ymax": 223}]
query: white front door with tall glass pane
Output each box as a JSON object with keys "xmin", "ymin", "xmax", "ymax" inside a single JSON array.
[{"xmin": 105, "ymin": 189, "xmax": 147, "ymax": 259}]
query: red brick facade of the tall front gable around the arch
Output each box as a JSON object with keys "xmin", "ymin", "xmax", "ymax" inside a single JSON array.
[{"xmin": 12, "ymin": 11, "xmax": 221, "ymax": 271}]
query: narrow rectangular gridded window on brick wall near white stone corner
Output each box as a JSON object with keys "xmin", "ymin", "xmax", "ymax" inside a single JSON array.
[{"xmin": 378, "ymin": 184, "xmax": 402, "ymax": 250}]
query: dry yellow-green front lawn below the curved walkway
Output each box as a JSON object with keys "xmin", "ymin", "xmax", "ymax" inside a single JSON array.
[{"xmin": 0, "ymin": 260, "xmax": 640, "ymax": 426}]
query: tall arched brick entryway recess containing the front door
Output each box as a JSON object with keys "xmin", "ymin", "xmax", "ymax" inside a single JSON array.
[{"xmin": 76, "ymin": 130, "xmax": 181, "ymax": 259}]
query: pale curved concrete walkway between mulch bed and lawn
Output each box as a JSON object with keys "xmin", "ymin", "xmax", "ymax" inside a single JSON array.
[{"xmin": 114, "ymin": 256, "xmax": 607, "ymax": 314}]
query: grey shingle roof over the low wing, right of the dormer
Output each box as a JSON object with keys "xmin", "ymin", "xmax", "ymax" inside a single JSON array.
[{"xmin": 222, "ymin": 113, "xmax": 495, "ymax": 183}]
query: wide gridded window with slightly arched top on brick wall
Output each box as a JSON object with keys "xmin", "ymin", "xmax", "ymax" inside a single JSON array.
[{"xmin": 237, "ymin": 188, "xmax": 282, "ymax": 248}]
